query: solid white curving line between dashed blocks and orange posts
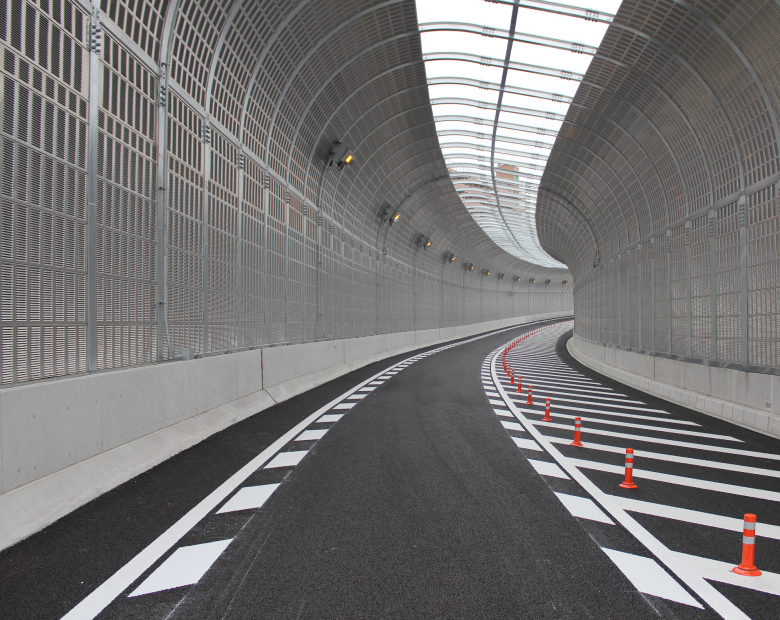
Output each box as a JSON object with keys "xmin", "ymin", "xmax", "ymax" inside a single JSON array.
[{"xmin": 490, "ymin": 348, "xmax": 750, "ymax": 620}]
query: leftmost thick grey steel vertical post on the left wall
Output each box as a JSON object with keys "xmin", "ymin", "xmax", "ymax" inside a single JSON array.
[{"xmin": 86, "ymin": 9, "xmax": 102, "ymax": 372}]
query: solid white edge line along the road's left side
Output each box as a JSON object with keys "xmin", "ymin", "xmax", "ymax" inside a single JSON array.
[{"xmin": 61, "ymin": 323, "xmax": 568, "ymax": 620}]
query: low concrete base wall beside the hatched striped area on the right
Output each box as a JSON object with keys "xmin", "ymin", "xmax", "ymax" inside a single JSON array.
[{"xmin": 568, "ymin": 335, "xmax": 780, "ymax": 437}]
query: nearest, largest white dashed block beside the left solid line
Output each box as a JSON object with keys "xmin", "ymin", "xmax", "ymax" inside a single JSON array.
[{"xmin": 129, "ymin": 538, "xmax": 233, "ymax": 596}]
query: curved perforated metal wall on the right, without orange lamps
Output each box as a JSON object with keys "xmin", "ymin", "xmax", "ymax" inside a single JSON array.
[{"xmin": 537, "ymin": 0, "xmax": 780, "ymax": 373}]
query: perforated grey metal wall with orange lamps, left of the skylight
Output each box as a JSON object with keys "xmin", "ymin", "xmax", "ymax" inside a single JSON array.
[{"xmin": 0, "ymin": 0, "xmax": 573, "ymax": 385}]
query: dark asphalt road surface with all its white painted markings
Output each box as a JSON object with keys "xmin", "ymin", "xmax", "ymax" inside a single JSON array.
[{"xmin": 0, "ymin": 322, "xmax": 780, "ymax": 620}]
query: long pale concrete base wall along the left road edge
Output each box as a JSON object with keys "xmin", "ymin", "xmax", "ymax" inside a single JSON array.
[{"xmin": 0, "ymin": 312, "xmax": 570, "ymax": 549}]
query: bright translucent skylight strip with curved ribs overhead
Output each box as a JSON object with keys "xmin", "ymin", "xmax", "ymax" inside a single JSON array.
[{"xmin": 417, "ymin": 0, "xmax": 620, "ymax": 267}]
